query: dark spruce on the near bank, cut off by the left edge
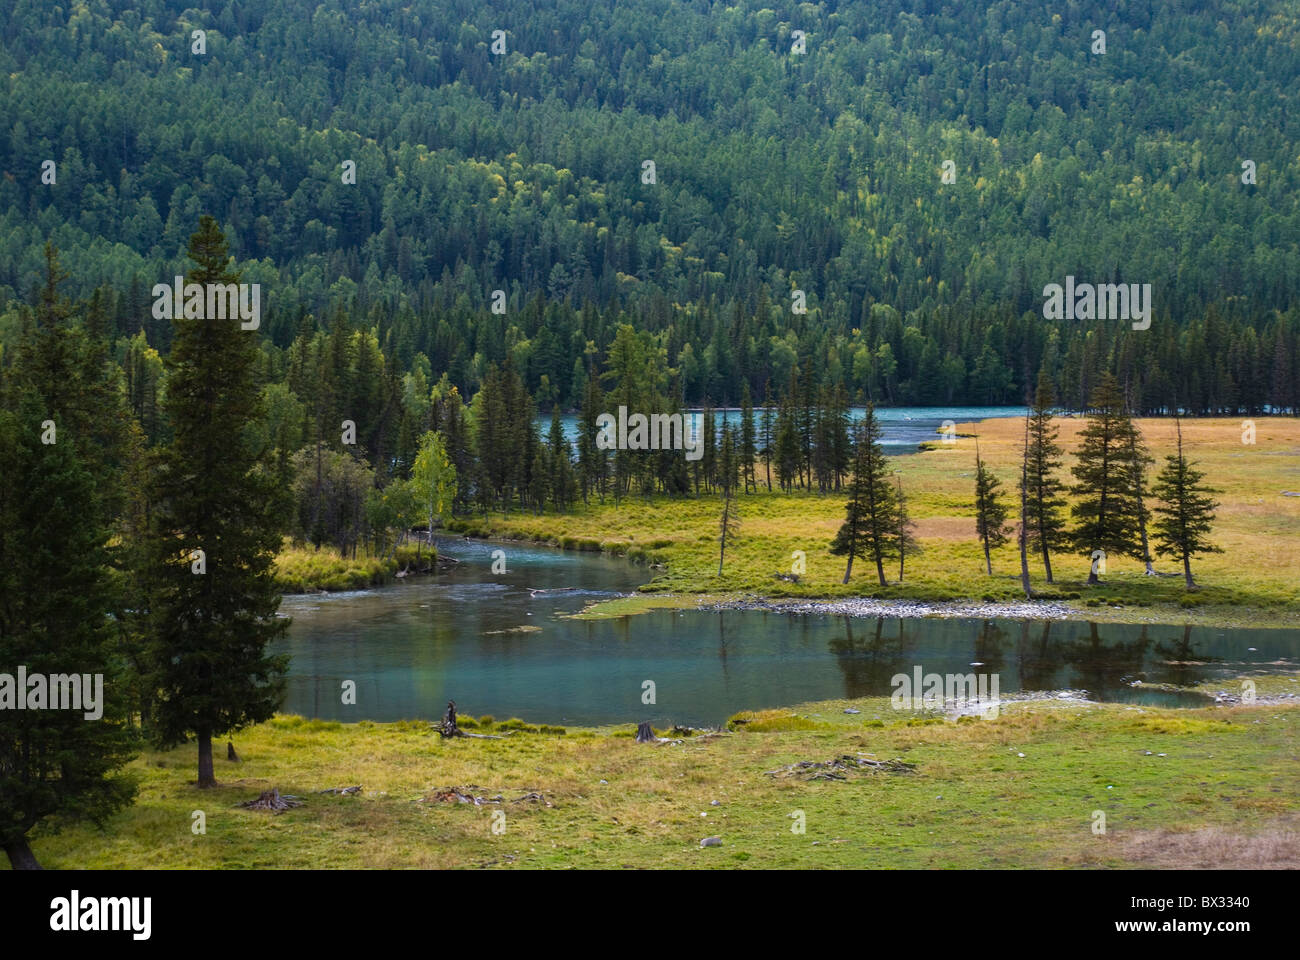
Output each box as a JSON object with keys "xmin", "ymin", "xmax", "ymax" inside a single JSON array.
[{"xmin": 0, "ymin": 245, "xmax": 135, "ymax": 869}]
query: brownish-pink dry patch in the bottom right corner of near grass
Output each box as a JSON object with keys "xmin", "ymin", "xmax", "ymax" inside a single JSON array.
[{"xmin": 1117, "ymin": 817, "xmax": 1300, "ymax": 870}]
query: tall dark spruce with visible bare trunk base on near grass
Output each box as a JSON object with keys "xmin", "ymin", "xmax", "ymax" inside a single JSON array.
[{"xmin": 150, "ymin": 216, "xmax": 289, "ymax": 787}]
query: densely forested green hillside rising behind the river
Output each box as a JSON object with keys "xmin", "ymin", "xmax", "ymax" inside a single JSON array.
[{"xmin": 0, "ymin": 0, "xmax": 1300, "ymax": 414}]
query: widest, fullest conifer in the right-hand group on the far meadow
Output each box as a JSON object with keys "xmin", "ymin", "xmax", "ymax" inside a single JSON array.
[{"xmin": 1071, "ymin": 372, "xmax": 1141, "ymax": 584}]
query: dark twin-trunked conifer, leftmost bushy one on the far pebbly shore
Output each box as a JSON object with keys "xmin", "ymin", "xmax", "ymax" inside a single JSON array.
[{"xmin": 831, "ymin": 405, "xmax": 898, "ymax": 587}]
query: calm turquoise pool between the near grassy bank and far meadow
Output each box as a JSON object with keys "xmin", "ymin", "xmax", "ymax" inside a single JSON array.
[{"xmin": 281, "ymin": 540, "xmax": 1300, "ymax": 726}]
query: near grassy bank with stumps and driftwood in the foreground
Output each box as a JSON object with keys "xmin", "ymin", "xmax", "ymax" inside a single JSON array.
[{"xmin": 22, "ymin": 673, "xmax": 1300, "ymax": 869}]
